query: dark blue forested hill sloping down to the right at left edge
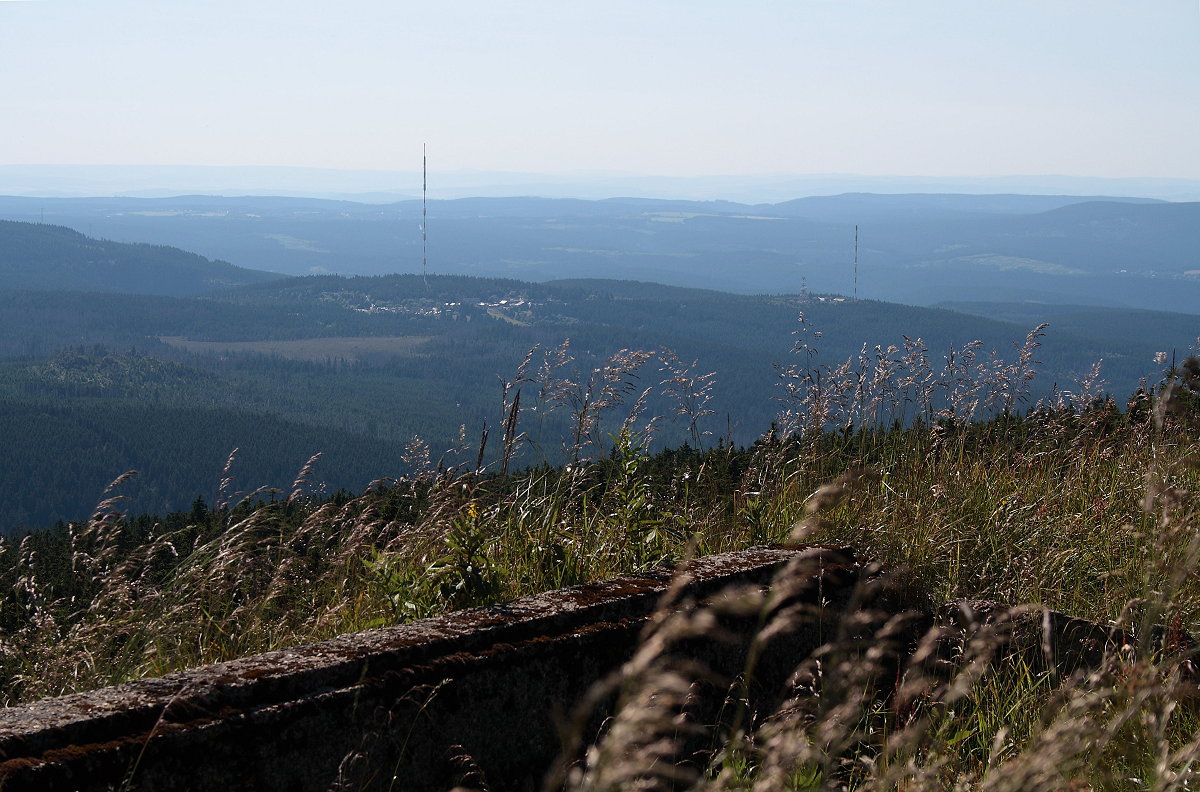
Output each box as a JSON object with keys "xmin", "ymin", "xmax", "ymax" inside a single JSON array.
[{"xmin": 0, "ymin": 220, "xmax": 281, "ymax": 295}]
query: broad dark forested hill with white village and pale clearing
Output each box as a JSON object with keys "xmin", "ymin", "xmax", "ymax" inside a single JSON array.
[{"xmin": 0, "ymin": 266, "xmax": 1196, "ymax": 533}]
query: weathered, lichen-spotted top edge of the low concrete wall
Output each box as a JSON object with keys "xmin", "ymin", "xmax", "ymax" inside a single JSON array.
[{"xmin": 0, "ymin": 547, "xmax": 811, "ymax": 762}]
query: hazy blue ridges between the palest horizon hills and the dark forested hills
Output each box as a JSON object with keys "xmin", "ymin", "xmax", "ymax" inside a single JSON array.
[{"xmin": 0, "ymin": 193, "xmax": 1200, "ymax": 313}]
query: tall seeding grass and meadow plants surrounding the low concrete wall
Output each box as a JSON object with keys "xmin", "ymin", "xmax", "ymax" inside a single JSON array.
[{"xmin": 0, "ymin": 318, "xmax": 1200, "ymax": 790}]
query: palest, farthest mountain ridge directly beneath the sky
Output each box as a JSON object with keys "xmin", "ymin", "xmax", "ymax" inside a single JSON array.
[{"xmin": 0, "ymin": 160, "xmax": 1200, "ymax": 204}]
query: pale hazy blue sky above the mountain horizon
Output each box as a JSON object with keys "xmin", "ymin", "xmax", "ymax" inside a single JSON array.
[{"xmin": 0, "ymin": 0, "xmax": 1200, "ymax": 179}]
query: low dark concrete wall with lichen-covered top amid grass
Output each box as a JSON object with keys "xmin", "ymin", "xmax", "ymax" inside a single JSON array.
[{"xmin": 0, "ymin": 548, "xmax": 863, "ymax": 792}]
